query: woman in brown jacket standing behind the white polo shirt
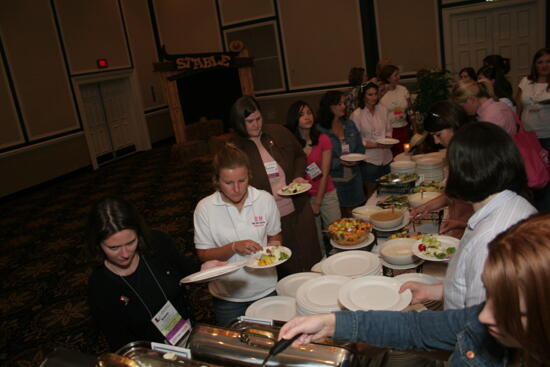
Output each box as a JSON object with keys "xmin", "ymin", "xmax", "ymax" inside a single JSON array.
[{"xmin": 231, "ymin": 96, "xmax": 321, "ymax": 278}]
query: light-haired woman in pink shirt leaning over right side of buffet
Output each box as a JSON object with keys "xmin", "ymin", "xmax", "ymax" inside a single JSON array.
[{"xmin": 452, "ymin": 80, "xmax": 516, "ymax": 136}]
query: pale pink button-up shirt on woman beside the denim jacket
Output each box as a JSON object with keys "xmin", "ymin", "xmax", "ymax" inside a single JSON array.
[{"xmin": 350, "ymin": 103, "xmax": 393, "ymax": 166}]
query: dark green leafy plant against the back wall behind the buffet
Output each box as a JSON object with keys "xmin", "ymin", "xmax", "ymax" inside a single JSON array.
[{"xmin": 412, "ymin": 69, "xmax": 452, "ymax": 117}]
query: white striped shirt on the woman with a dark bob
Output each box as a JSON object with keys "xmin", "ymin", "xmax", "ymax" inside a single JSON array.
[{"xmin": 443, "ymin": 190, "xmax": 537, "ymax": 309}]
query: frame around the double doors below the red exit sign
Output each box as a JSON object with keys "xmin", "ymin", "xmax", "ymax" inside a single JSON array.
[{"xmin": 72, "ymin": 70, "xmax": 151, "ymax": 169}]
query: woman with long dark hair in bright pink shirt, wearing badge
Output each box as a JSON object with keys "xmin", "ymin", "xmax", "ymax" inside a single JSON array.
[{"xmin": 286, "ymin": 101, "xmax": 342, "ymax": 255}]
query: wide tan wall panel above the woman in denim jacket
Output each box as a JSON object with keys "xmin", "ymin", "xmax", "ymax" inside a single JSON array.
[{"xmin": 278, "ymin": 0, "xmax": 365, "ymax": 89}]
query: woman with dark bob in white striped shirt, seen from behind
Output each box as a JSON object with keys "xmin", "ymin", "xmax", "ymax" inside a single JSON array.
[{"xmin": 401, "ymin": 122, "xmax": 536, "ymax": 309}]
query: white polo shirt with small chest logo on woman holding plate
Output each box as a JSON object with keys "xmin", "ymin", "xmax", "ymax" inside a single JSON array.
[{"xmin": 193, "ymin": 186, "xmax": 281, "ymax": 302}]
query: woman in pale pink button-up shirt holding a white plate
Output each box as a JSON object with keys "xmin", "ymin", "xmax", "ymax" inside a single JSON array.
[{"xmin": 350, "ymin": 82, "xmax": 393, "ymax": 198}]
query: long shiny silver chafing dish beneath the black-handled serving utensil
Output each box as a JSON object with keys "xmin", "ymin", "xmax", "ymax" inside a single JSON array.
[{"xmin": 187, "ymin": 322, "xmax": 354, "ymax": 367}]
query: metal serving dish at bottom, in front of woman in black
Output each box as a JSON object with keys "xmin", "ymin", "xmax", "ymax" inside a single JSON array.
[{"xmin": 113, "ymin": 341, "xmax": 219, "ymax": 367}]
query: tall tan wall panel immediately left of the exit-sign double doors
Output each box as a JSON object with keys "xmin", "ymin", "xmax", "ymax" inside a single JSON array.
[{"xmin": 0, "ymin": 0, "xmax": 78, "ymax": 140}]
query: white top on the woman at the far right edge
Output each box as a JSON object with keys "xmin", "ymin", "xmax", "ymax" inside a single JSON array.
[{"xmin": 519, "ymin": 77, "xmax": 550, "ymax": 139}]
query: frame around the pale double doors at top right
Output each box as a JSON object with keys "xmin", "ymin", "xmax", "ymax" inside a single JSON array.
[{"xmin": 442, "ymin": 0, "xmax": 546, "ymax": 75}]
